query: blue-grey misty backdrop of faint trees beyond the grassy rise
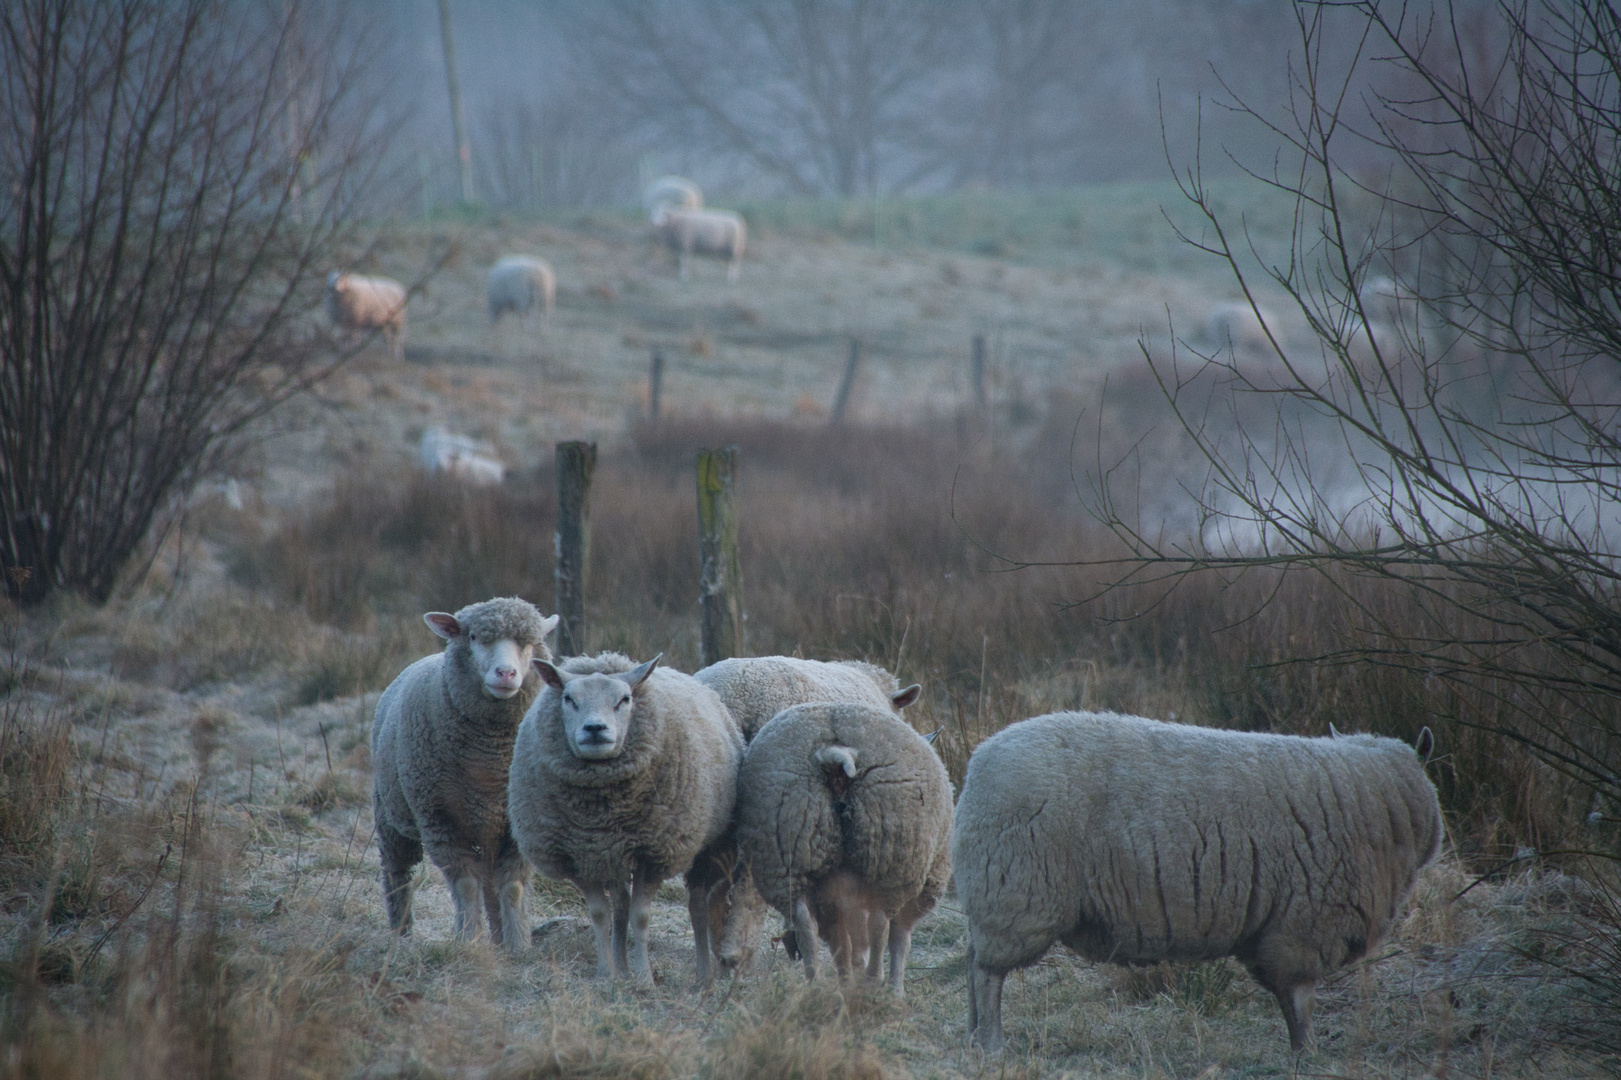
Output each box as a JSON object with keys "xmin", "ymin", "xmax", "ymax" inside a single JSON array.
[{"xmin": 368, "ymin": 0, "xmax": 1387, "ymax": 212}]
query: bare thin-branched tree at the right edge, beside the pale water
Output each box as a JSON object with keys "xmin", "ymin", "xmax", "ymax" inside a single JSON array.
[{"xmin": 1097, "ymin": 0, "xmax": 1621, "ymax": 814}]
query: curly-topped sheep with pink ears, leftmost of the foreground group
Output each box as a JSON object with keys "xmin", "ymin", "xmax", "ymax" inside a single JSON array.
[{"xmin": 371, "ymin": 597, "xmax": 558, "ymax": 954}]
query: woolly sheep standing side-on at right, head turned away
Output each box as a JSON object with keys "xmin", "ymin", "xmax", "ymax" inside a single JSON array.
[{"xmin": 952, "ymin": 712, "xmax": 1443, "ymax": 1051}]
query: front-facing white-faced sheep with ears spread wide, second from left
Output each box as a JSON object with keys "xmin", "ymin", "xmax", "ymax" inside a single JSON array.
[{"xmin": 507, "ymin": 652, "xmax": 742, "ymax": 983}]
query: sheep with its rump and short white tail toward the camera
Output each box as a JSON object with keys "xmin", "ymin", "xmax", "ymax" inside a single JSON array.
[{"xmin": 738, "ymin": 702, "xmax": 952, "ymax": 996}]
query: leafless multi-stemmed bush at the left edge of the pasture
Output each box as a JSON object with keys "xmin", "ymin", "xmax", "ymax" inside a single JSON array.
[{"xmin": 0, "ymin": 0, "xmax": 392, "ymax": 602}]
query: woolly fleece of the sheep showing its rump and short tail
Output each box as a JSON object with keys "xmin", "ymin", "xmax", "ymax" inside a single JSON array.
[{"xmin": 738, "ymin": 702, "xmax": 952, "ymax": 924}]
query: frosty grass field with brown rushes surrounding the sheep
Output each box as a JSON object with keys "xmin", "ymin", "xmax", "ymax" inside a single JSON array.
[{"xmin": 0, "ymin": 188, "xmax": 1621, "ymax": 1080}]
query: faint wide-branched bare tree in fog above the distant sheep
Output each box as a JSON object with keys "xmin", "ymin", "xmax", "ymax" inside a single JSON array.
[{"xmin": 577, "ymin": 0, "xmax": 961, "ymax": 196}]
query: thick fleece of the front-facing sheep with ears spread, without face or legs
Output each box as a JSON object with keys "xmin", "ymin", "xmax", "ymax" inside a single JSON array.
[{"xmin": 507, "ymin": 652, "xmax": 742, "ymax": 882}]
